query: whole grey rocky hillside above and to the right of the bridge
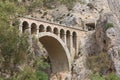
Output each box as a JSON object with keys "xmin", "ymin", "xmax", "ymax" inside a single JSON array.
[{"xmin": 19, "ymin": 0, "xmax": 120, "ymax": 80}]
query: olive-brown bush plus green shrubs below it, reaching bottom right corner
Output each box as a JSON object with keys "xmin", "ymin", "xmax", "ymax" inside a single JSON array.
[{"xmin": 86, "ymin": 52, "xmax": 120, "ymax": 80}]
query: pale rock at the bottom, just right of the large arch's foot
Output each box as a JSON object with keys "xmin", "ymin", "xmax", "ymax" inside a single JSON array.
[{"xmin": 72, "ymin": 55, "xmax": 89, "ymax": 80}]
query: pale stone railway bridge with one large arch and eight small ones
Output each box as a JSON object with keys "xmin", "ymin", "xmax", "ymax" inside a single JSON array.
[{"xmin": 19, "ymin": 17, "xmax": 84, "ymax": 72}]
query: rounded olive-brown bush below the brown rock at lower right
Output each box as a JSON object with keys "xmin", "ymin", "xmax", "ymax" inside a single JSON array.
[{"xmin": 86, "ymin": 52, "xmax": 112, "ymax": 75}]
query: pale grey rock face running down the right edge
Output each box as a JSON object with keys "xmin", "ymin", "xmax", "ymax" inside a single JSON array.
[{"xmin": 107, "ymin": 0, "xmax": 120, "ymax": 76}]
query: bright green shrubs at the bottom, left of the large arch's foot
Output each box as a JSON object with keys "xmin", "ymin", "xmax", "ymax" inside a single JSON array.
[{"xmin": 11, "ymin": 62, "xmax": 48, "ymax": 80}]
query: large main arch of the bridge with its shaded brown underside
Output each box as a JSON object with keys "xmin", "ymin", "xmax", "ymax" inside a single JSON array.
[{"xmin": 39, "ymin": 32, "xmax": 71, "ymax": 73}]
